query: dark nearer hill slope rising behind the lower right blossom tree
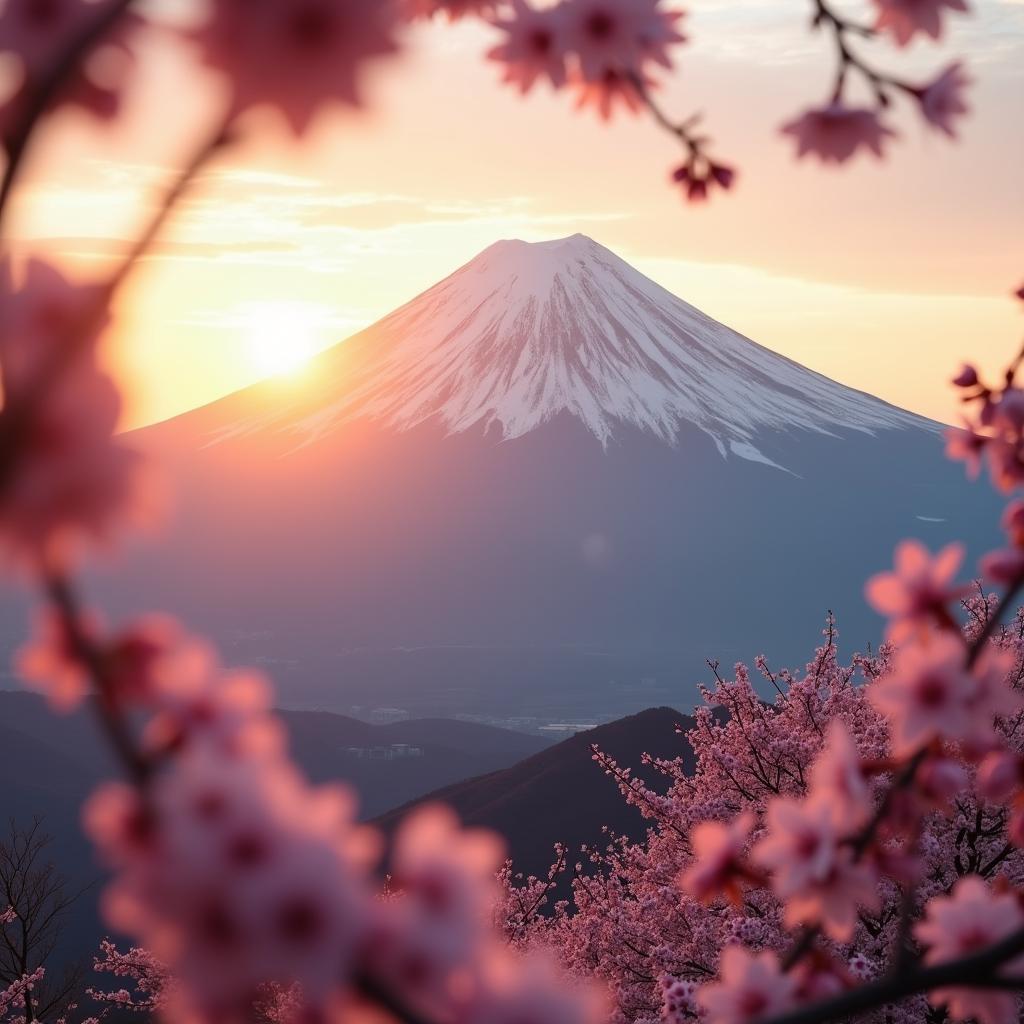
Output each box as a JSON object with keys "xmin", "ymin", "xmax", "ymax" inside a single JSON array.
[{"xmin": 377, "ymin": 708, "xmax": 694, "ymax": 874}]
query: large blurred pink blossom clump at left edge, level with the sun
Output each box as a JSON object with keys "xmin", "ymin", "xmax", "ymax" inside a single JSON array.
[{"xmin": 0, "ymin": 252, "xmax": 153, "ymax": 563}]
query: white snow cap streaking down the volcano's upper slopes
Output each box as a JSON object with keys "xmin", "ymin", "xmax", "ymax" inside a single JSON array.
[{"xmin": 205, "ymin": 234, "xmax": 931, "ymax": 465}]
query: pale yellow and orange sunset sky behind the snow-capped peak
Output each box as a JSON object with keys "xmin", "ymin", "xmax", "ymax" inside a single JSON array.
[{"xmin": 8, "ymin": 0, "xmax": 1024, "ymax": 427}]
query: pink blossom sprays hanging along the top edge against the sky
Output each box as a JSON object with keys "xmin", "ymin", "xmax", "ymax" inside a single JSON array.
[{"xmin": 0, "ymin": 0, "xmax": 970, "ymax": 215}]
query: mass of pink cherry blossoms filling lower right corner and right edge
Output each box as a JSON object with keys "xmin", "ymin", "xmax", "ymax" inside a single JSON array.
[{"xmin": 497, "ymin": 337, "xmax": 1024, "ymax": 1024}]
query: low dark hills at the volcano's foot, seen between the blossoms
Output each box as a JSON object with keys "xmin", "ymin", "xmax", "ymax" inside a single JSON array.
[{"xmin": 0, "ymin": 692, "xmax": 693, "ymax": 954}]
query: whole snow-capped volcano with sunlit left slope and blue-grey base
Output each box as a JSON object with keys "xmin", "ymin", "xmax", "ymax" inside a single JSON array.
[{"xmin": 22, "ymin": 236, "xmax": 998, "ymax": 724}]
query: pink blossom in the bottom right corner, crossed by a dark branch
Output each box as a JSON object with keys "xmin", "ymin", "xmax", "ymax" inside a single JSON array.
[{"xmin": 914, "ymin": 876, "xmax": 1024, "ymax": 1024}]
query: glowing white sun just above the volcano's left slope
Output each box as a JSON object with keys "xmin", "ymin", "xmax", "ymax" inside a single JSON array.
[{"xmin": 239, "ymin": 302, "xmax": 327, "ymax": 377}]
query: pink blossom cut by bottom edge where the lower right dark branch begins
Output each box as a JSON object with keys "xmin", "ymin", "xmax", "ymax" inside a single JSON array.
[{"xmin": 697, "ymin": 946, "xmax": 797, "ymax": 1024}]
